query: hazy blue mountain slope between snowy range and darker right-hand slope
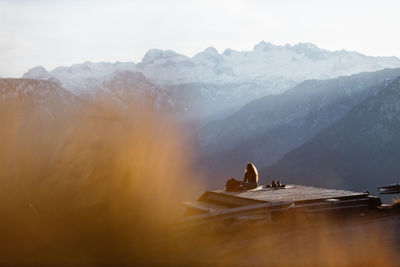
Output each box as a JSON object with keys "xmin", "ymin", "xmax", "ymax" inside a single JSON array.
[{"xmin": 198, "ymin": 69, "xmax": 400, "ymax": 186}]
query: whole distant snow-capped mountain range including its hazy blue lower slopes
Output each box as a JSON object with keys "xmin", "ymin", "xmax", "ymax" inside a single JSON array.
[{"xmin": 23, "ymin": 42, "xmax": 400, "ymax": 122}]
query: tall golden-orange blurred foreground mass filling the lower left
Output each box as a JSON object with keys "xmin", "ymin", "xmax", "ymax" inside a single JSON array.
[{"xmin": 0, "ymin": 102, "xmax": 202, "ymax": 265}]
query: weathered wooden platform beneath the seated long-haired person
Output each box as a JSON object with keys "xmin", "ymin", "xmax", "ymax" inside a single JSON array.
[{"xmin": 182, "ymin": 184, "xmax": 380, "ymax": 227}]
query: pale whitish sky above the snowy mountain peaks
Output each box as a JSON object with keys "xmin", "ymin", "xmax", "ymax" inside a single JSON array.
[{"xmin": 0, "ymin": 0, "xmax": 400, "ymax": 77}]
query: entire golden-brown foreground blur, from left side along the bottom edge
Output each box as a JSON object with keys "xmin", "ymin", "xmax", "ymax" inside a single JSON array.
[{"xmin": 0, "ymin": 101, "xmax": 398, "ymax": 266}]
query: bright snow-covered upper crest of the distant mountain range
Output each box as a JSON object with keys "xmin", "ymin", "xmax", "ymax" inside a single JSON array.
[{"xmin": 23, "ymin": 41, "xmax": 400, "ymax": 95}]
